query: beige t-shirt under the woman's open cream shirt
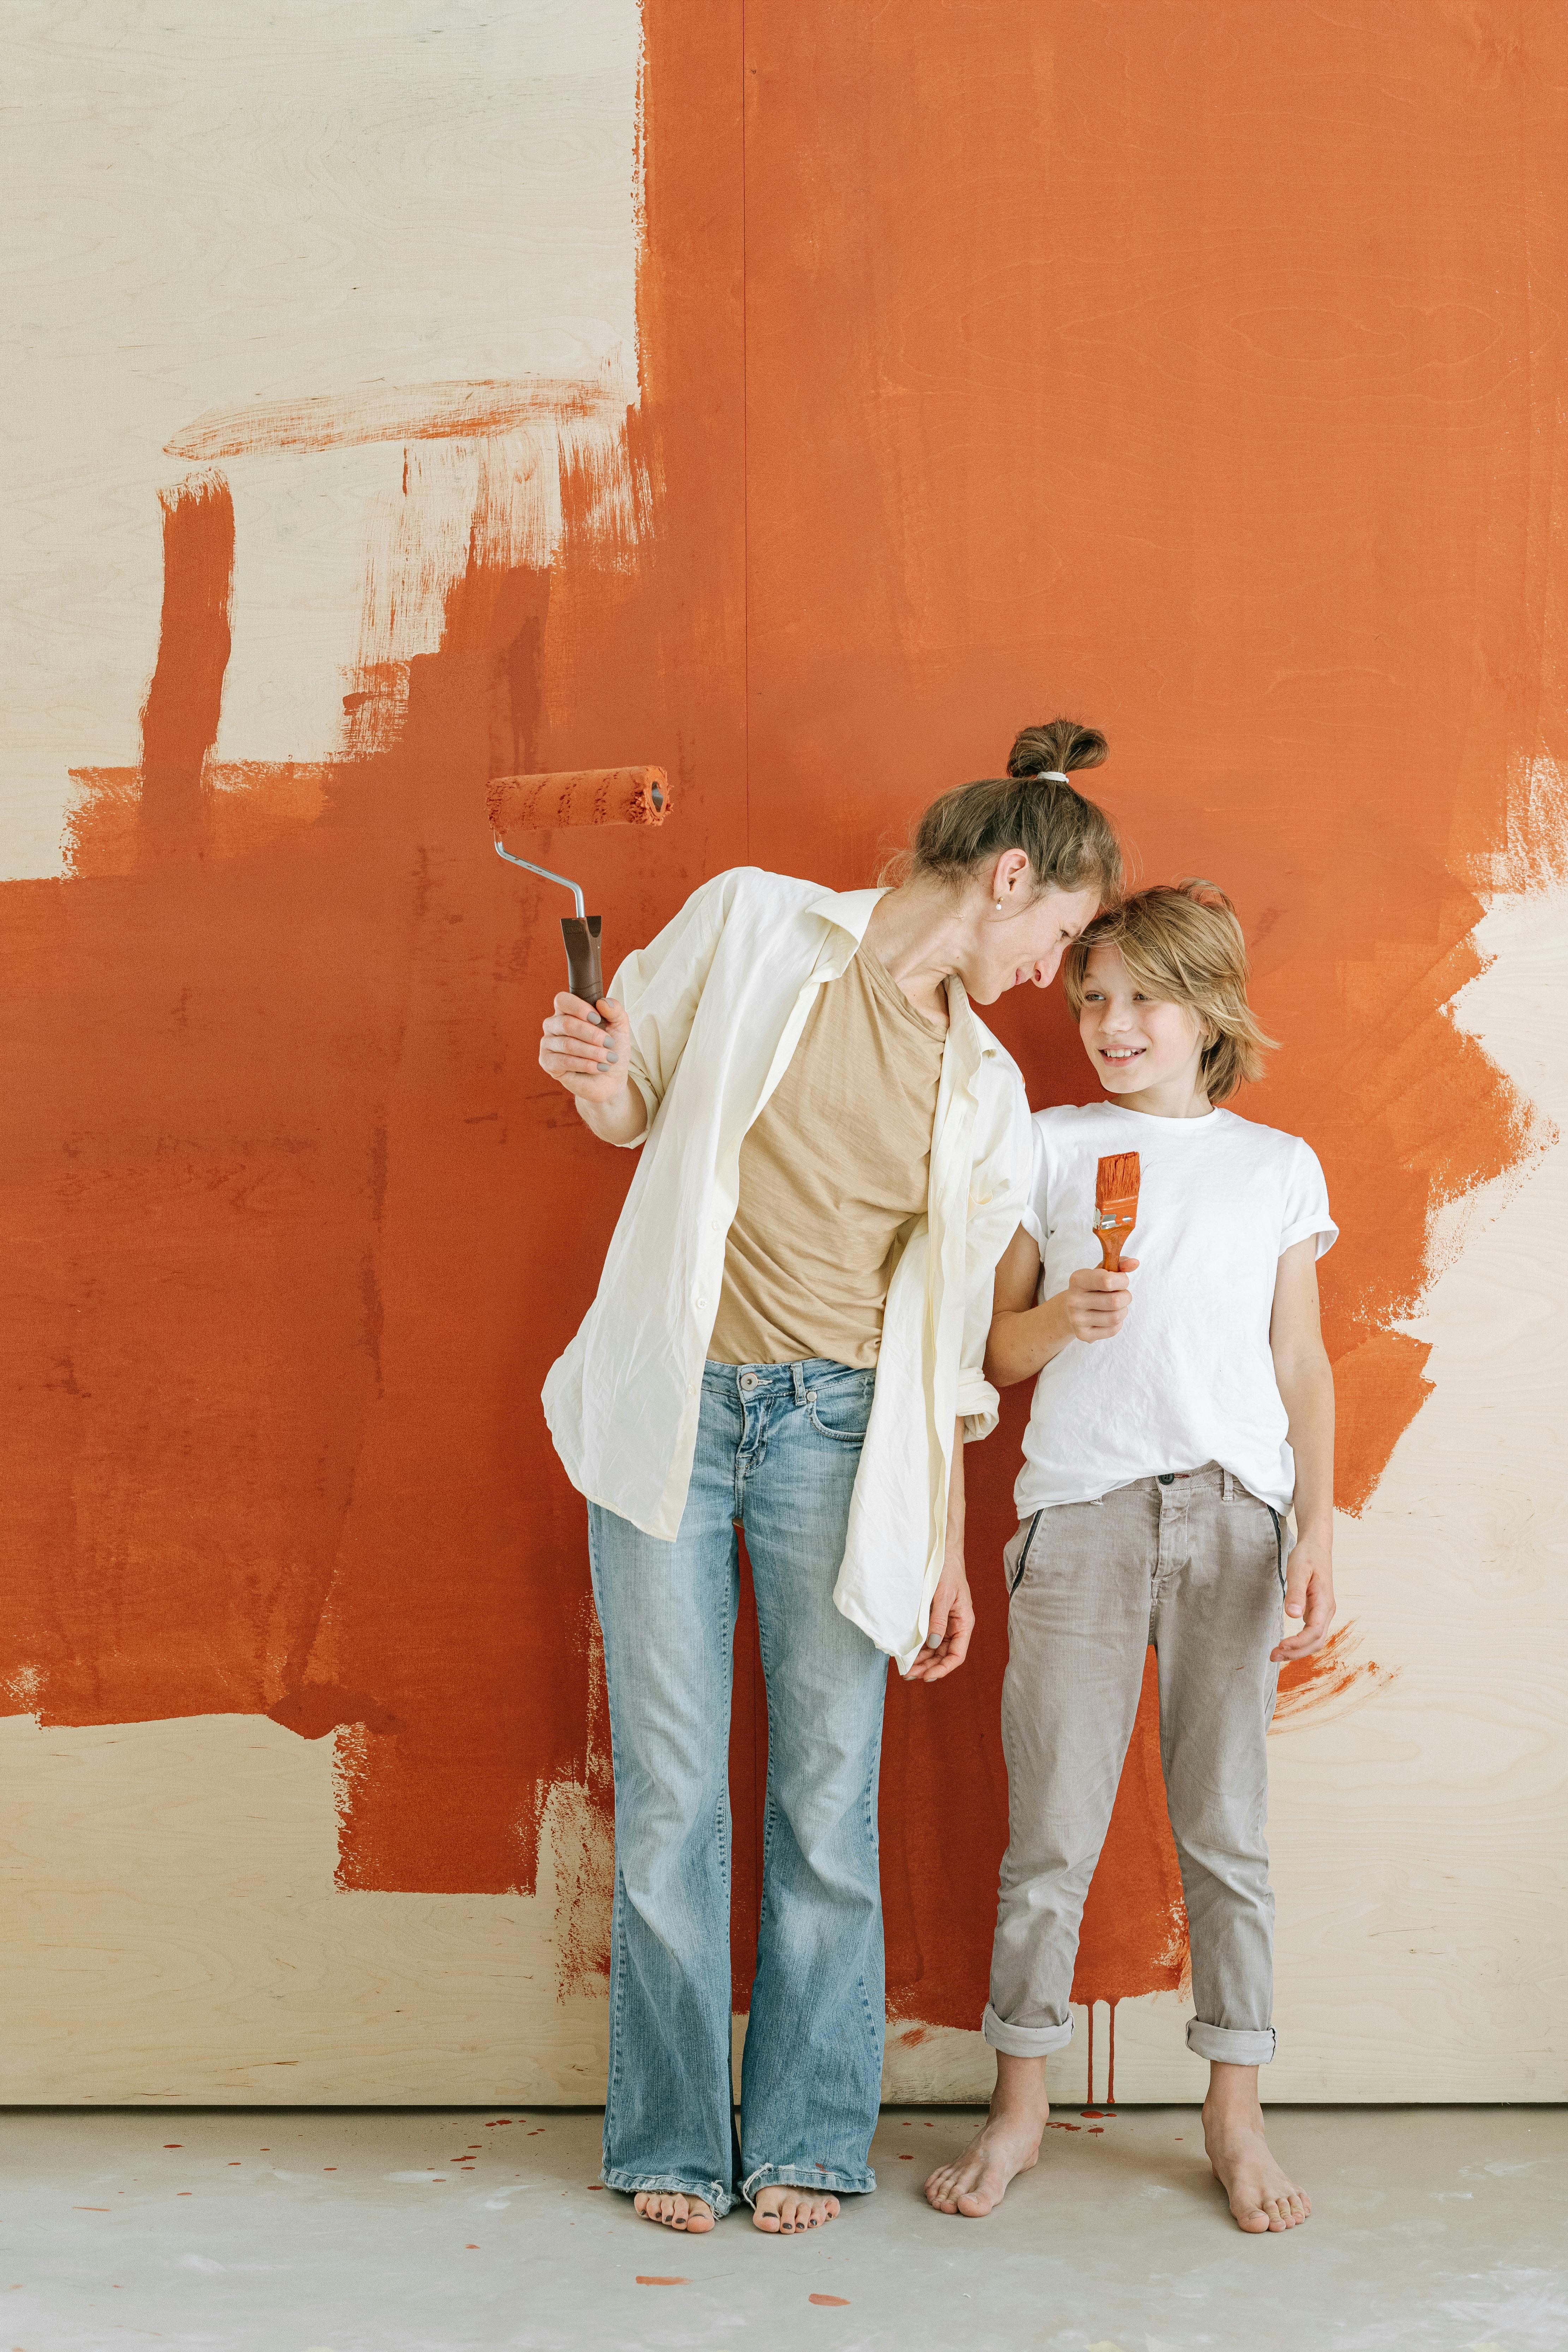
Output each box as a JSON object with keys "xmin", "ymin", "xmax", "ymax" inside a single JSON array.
[{"xmin": 708, "ymin": 948, "xmax": 947, "ymax": 1364}]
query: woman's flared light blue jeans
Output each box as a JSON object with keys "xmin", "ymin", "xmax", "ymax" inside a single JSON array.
[{"xmin": 588, "ymin": 1359, "xmax": 889, "ymax": 2213}]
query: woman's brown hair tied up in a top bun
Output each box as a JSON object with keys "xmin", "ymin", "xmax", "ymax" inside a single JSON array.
[{"xmin": 884, "ymin": 720, "xmax": 1121, "ymax": 898}]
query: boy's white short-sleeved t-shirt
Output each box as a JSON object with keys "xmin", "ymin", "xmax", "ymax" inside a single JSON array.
[{"xmin": 1013, "ymin": 1103, "xmax": 1340, "ymax": 1520}]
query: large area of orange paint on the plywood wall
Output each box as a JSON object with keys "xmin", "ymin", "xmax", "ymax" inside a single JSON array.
[{"xmin": 0, "ymin": 0, "xmax": 1568, "ymax": 2025}]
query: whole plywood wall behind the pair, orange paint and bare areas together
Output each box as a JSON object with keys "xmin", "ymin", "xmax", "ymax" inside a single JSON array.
[{"xmin": 0, "ymin": 0, "xmax": 1568, "ymax": 2100}]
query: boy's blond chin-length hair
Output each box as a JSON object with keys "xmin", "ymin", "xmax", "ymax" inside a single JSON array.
[{"xmin": 1063, "ymin": 882, "xmax": 1274, "ymax": 1103}]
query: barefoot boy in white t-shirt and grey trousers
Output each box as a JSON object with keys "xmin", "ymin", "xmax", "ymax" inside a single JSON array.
[{"xmin": 926, "ymin": 882, "xmax": 1338, "ymax": 2232}]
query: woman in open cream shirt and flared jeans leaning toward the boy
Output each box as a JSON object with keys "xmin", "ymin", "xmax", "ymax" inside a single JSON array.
[{"xmin": 538, "ymin": 720, "xmax": 1121, "ymax": 2234}]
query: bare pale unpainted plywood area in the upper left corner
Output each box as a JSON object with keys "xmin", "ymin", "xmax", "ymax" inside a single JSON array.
[{"xmin": 0, "ymin": 0, "xmax": 639, "ymax": 875}]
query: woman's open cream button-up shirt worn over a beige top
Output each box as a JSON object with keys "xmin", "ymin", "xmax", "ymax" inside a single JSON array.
[{"xmin": 543, "ymin": 866, "xmax": 1030, "ymax": 1670}]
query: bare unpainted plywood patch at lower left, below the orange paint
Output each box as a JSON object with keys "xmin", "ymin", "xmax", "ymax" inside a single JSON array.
[{"xmin": 0, "ymin": 1715, "xmax": 604, "ymax": 2105}]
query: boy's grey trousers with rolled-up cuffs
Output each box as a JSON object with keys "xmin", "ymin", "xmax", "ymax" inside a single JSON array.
[{"xmin": 983, "ymin": 1463, "xmax": 1286, "ymax": 2065}]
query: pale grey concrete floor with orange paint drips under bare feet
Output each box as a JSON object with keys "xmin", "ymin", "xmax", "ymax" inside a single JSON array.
[{"xmin": 0, "ymin": 2107, "xmax": 1568, "ymax": 2352}]
